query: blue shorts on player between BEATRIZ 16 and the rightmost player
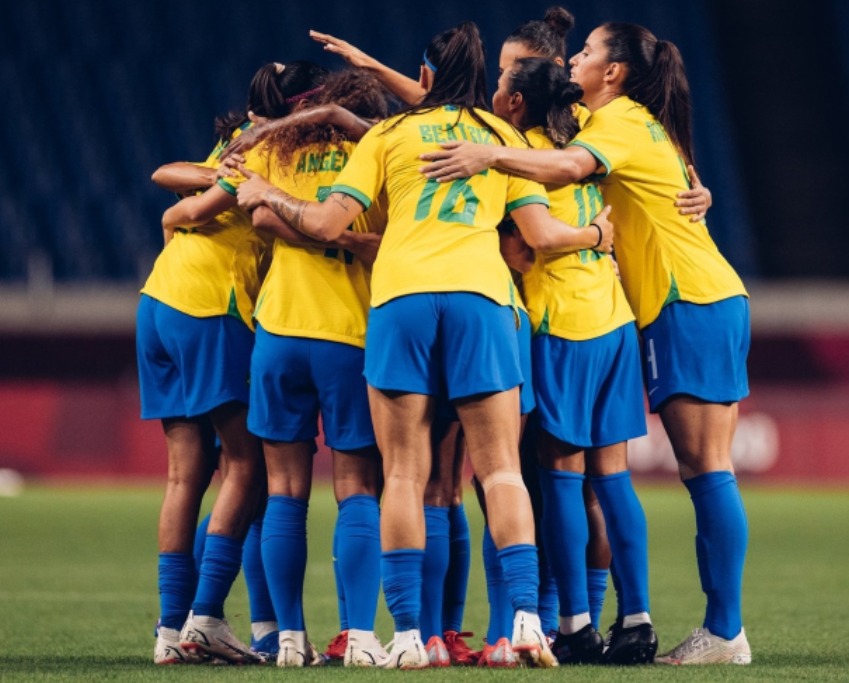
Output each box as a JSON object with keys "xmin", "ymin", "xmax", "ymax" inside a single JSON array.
[{"xmin": 533, "ymin": 323, "xmax": 647, "ymax": 448}]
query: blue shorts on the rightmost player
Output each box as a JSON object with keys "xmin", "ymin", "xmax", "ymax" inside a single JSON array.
[{"xmin": 642, "ymin": 296, "xmax": 751, "ymax": 413}]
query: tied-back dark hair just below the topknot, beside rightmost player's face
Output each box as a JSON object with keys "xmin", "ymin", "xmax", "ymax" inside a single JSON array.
[{"xmin": 509, "ymin": 57, "xmax": 584, "ymax": 147}]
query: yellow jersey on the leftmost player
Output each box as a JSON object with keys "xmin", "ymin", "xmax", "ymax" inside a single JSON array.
[{"xmin": 141, "ymin": 129, "xmax": 271, "ymax": 329}]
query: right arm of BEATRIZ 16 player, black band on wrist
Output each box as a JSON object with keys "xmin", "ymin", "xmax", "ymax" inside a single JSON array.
[{"xmin": 510, "ymin": 204, "xmax": 613, "ymax": 254}]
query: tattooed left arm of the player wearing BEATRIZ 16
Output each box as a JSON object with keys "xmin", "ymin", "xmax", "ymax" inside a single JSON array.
[{"xmin": 237, "ymin": 166, "xmax": 365, "ymax": 243}]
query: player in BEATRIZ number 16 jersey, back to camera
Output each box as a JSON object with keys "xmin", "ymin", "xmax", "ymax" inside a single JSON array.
[{"xmin": 239, "ymin": 22, "xmax": 612, "ymax": 668}]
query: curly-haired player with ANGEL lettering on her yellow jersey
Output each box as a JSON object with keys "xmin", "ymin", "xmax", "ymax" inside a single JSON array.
[{"xmin": 219, "ymin": 71, "xmax": 387, "ymax": 667}]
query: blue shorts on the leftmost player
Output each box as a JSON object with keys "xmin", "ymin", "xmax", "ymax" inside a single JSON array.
[{"xmin": 136, "ymin": 294, "xmax": 254, "ymax": 420}]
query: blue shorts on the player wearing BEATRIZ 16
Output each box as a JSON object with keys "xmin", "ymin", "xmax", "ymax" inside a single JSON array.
[{"xmin": 366, "ymin": 292, "xmax": 522, "ymax": 401}]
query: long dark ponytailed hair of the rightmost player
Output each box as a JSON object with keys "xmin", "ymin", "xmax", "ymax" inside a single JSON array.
[{"xmin": 602, "ymin": 23, "xmax": 695, "ymax": 164}]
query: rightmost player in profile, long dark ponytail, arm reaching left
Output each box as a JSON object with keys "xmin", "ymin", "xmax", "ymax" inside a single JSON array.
[{"xmin": 426, "ymin": 23, "xmax": 751, "ymax": 664}]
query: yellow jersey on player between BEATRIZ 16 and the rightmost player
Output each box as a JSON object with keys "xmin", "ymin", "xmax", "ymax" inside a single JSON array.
[{"xmin": 522, "ymin": 127, "xmax": 634, "ymax": 341}]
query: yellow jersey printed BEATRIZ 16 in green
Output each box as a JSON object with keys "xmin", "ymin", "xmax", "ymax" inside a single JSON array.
[{"xmin": 324, "ymin": 106, "xmax": 548, "ymax": 307}]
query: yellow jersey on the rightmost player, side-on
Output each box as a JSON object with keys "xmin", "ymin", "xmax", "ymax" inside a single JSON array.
[{"xmin": 570, "ymin": 96, "xmax": 746, "ymax": 328}]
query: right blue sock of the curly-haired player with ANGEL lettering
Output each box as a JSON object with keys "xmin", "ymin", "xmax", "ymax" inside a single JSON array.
[{"xmin": 334, "ymin": 495, "xmax": 380, "ymax": 631}]
